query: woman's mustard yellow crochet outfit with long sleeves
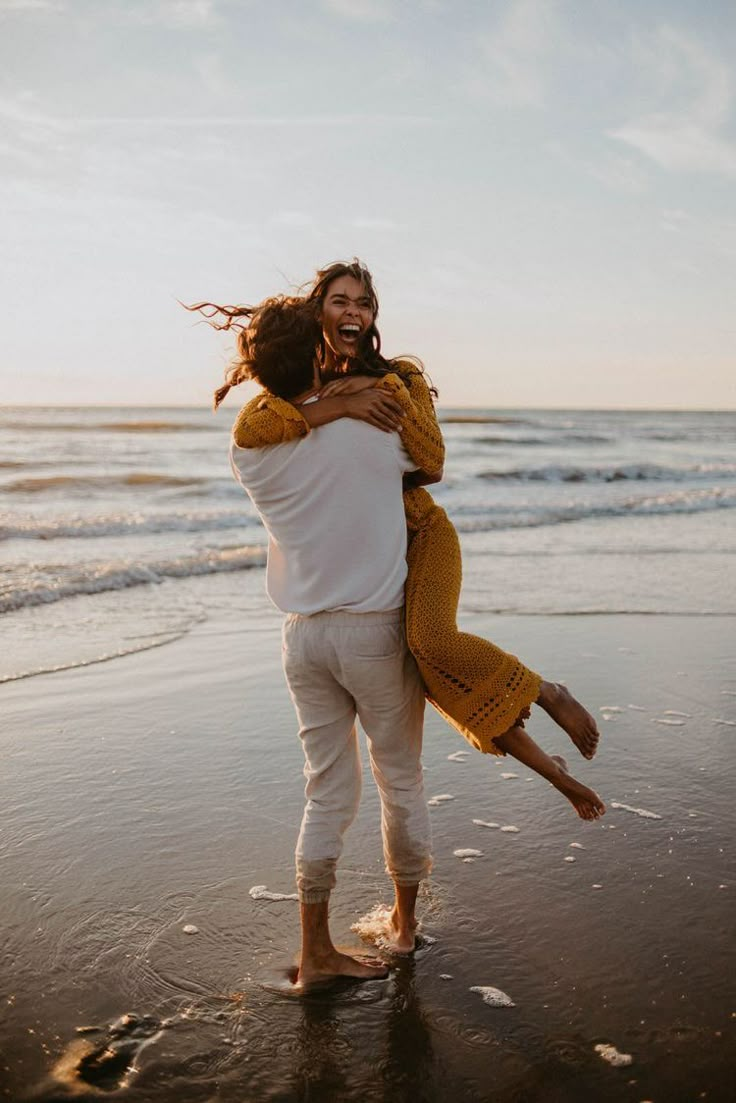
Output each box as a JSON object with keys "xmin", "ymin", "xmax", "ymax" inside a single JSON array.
[{"xmin": 233, "ymin": 362, "xmax": 542, "ymax": 754}]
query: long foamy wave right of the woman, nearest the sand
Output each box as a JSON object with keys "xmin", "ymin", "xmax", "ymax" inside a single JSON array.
[{"xmin": 452, "ymin": 486, "xmax": 736, "ymax": 533}]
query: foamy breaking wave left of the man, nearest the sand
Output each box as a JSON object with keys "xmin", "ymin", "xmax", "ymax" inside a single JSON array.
[{"xmin": 0, "ymin": 546, "xmax": 266, "ymax": 613}]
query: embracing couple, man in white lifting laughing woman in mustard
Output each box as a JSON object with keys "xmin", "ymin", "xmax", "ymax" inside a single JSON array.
[{"xmin": 190, "ymin": 260, "xmax": 605, "ymax": 987}]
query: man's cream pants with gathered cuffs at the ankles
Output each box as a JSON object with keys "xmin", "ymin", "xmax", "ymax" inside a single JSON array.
[{"xmin": 284, "ymin": 609, "xmax": 431, "ymax": 903}]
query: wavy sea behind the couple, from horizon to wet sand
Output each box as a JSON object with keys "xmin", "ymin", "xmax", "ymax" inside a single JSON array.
[{"xmin": 0, "ymin": 407, "xmax": 736, "ymax": 681}]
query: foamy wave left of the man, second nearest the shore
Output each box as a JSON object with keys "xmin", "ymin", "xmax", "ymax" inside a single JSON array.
[{"xmin": 0, "ymin": 508, "xmax": 260, "ymax": 540}]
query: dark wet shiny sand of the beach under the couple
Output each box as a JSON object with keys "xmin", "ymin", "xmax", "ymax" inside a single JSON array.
[{"xmin": 0, "ymin": 572, "xmax": 736, "ymax": 1103}]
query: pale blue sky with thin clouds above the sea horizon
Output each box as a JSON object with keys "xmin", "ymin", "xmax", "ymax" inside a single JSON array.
[{"xmin": 0, "ymin": 0, "xmax": 736, "ymax": 409}]
